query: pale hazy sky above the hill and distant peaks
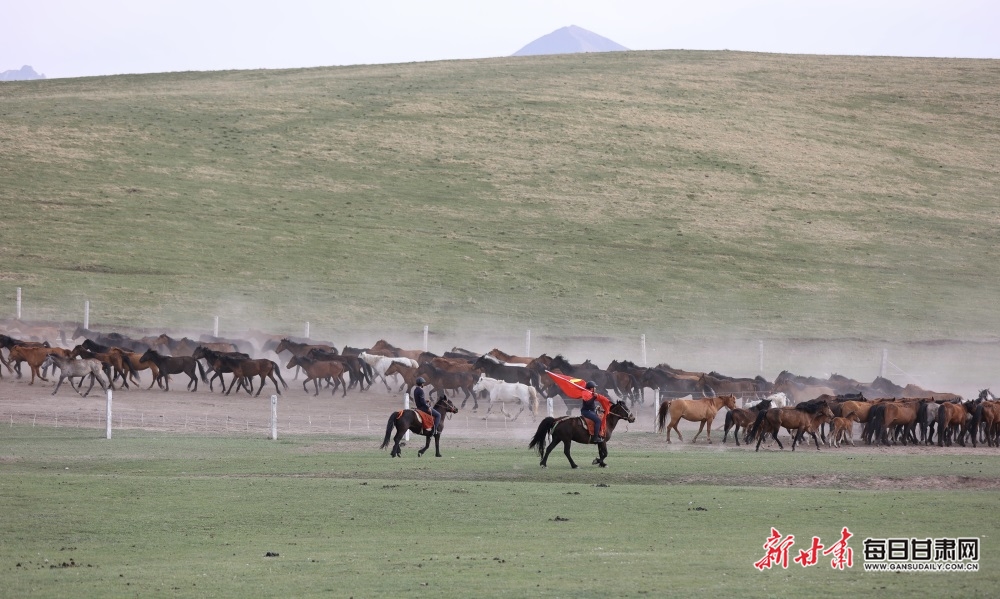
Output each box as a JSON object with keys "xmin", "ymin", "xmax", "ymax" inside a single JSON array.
[{"xmin": 0, "ymin": 0, "xmax": 1000, "ymax": 78}]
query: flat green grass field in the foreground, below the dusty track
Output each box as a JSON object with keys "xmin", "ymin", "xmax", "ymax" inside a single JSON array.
[{"xmin": 0, "ymin": 426, "xmax": 1000, "ymax": 597}]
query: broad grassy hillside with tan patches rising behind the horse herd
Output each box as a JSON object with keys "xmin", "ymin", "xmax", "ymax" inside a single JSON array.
[{"xmin": 0, "ymin": 51, "xmax": 1000, "ymax": 352}]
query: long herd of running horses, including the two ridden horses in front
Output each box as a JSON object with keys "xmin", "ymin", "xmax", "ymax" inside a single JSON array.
[{"xmin": 0, "ymin": 327, "xmax": 1000, "ymax": 467}]
